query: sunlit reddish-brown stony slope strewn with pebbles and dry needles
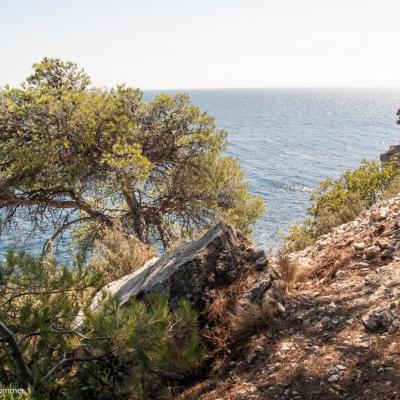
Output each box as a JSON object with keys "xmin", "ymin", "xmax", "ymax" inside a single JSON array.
[{"xmin": 180, "ymin": 196, "xmax": 400, "ymax": 400}]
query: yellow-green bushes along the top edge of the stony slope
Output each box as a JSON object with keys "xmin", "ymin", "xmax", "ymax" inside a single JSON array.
[{"xmin": 286, "ymin": 160, "xmax": 400, "ymax": 251}]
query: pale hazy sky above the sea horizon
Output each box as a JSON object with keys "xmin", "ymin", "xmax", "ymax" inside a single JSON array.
[{"xmin": 0, "ymin": 0, "xmax": 400, "ymax": 89}]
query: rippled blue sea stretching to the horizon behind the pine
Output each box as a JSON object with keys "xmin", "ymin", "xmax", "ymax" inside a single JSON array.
[{"xmin": 0, "ymin": 88, "xmax": 400, "ymax": 258}]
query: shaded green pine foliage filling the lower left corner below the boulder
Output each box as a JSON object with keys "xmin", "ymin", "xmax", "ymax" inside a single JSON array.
[{"xmin": 0, "ymin": 252, "xmax": 205, "ymax": 400}]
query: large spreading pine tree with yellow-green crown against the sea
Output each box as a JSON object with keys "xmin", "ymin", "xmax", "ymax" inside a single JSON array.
[{"xmin": 0, "ymin": 58, "xmax": 264, "ymax": 247}]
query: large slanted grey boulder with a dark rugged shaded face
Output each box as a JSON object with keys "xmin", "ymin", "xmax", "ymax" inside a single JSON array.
[{"xmin": 83, "ymin": 223, "xmax": 284, "ymax": 324}]
